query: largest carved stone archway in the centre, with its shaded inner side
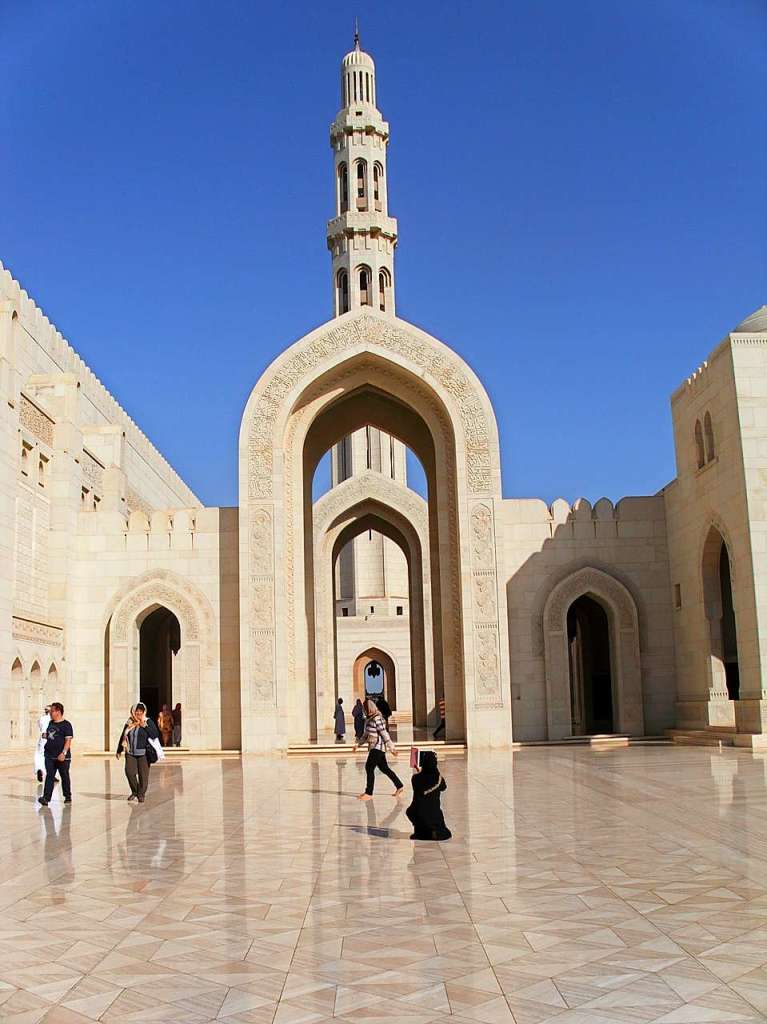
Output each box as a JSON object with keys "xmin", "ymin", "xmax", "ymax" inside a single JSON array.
[{"xmin": 240, "ymin": 310, "xmax": 511, "ymax": 750}]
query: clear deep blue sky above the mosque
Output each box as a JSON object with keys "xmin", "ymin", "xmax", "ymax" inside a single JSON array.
[{"xmin": 0, "ymin": 0, "xmax": 767, "ymax": 505}]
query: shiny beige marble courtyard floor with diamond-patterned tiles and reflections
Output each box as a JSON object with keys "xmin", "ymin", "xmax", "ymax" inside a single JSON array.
[{"xmin": 0, "ymin": 746, "xmax": 767, "ymax": 1024}]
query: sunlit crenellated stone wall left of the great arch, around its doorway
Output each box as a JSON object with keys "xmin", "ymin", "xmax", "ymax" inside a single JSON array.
[{"xmin": 67, "ymin": 508, "xmax": 240, "ymax": 750}]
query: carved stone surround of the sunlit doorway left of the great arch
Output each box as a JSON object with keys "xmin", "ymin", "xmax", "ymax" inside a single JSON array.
[{"xmin": 104, "ymin": 569, "xmax": 220, "ymax": 750}]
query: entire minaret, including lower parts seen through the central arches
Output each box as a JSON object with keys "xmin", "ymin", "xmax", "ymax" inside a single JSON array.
[{"xmin": 328, "ymin": 32, "xmax": 411, "ymax": 721}]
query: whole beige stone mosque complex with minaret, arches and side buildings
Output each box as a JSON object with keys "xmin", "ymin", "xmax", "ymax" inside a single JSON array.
[{"xmin": 0, "ymin": 38, "xmax": 767, "ymax": 763}]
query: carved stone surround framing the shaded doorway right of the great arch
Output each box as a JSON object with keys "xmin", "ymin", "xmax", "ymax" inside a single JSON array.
[{"xmin": 543, "ymin": 567, "xmax": 644, "ymax": 739}]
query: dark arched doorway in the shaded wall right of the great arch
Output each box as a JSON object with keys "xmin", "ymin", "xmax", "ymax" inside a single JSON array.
[{"xmin": 567, "ymin": 596, "xmax": 614, "ymax": 735}]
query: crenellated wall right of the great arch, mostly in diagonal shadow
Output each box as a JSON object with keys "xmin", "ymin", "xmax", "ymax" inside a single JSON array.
[{"xmin": 500, "ymin": 496, "xmax": 675, "ymax": 740}]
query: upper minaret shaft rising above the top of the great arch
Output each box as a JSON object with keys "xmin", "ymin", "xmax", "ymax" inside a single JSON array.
[{"xmin": 328, "ymin": 32, "xmax": 397, "ymax": 316}]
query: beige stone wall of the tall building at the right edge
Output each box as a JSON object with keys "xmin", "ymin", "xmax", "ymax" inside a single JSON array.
[{"xmin": 666, "ymin": 334, "xmax": 767, "ymax": 732}]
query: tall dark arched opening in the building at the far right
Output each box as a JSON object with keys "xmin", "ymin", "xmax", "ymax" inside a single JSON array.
[{"xmin": 702, "ymin": 526, "xmax": 740, "ymax": 700}]
